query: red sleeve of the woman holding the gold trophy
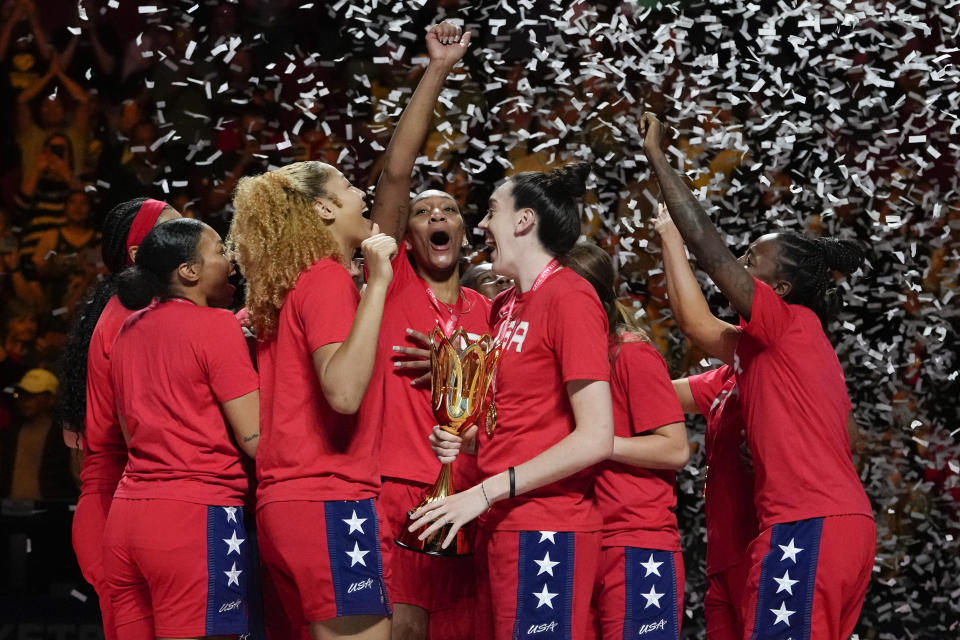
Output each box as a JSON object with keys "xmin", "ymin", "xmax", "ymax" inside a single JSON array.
[{"xmin": 543, "ymin": 276, "xmax": 610, "ymax": 382}]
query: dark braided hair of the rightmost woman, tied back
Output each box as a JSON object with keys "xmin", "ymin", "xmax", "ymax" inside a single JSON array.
[{"xmin": 777, "ymin": 231, "xmax": 864, "ymax": 327}]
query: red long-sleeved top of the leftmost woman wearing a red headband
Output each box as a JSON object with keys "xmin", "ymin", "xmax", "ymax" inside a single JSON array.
[{"xmin": 80, "ymin": 296, "xmax": 133, "ymax": 495}]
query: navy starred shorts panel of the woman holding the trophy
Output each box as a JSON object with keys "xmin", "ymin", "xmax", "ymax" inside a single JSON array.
[{"xmin": 513, "ymin": 531, "xmax": 574, "ymax": 640}]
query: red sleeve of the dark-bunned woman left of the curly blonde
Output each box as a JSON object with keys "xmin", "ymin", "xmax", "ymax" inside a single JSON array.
[{"xmin": 200, "ymin": 309, "xmax": 260, "ymax": 403}]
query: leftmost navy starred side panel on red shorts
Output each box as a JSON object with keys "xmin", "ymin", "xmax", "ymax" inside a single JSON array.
[{"xmin": 206, "ymin": 507, "xmax": 250, "ymax": 636}]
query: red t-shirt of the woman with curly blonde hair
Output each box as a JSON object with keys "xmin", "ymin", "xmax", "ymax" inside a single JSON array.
[{"xmin": 257, "ymin": 258, "xmax": 381, "ymax": 506}]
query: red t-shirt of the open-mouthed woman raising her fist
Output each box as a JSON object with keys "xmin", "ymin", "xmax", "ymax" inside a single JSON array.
[{"xmin": 361, "ymin": 243, "xmax": 490, "ymax": 483}]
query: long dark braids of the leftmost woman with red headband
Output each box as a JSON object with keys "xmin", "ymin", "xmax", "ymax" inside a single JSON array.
[{"xmin": 53, "ymin": 198, "xmax": 158, "ymax": 433}]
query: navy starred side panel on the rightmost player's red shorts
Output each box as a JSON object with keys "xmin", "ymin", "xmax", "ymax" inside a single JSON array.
[{"xmin": 750, "ymin": 518, "xmax": 823, "ymax": 640}]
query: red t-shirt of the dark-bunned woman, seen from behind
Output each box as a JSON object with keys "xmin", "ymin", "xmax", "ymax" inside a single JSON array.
[{"xmin": 110, "ymin": 299, "xmax": 258, "ymax": 505}]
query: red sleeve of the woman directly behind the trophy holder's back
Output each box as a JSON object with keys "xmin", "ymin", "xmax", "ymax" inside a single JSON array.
[{"xmin": 614, "ymin": 342, "xmax": 684, "ymax": 435}]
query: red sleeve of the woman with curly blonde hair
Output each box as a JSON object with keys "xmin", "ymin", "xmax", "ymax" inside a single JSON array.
[{"xmin": 298, "ymin": 261, "xmax": 360, "ymax": 353}]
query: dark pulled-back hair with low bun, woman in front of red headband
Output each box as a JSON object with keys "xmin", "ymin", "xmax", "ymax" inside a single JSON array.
[{"xmin": 117, "ymin": 218, "xmax": 205, "ymax": 309}]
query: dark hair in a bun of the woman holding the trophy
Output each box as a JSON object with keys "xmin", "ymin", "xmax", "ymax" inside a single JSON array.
[{"xmin": 509, "ymin": 163, "xmax": 590, "ymax": 256}]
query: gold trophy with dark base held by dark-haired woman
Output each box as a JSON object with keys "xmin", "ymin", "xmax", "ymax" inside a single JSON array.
[{"xmin": 396, "ymin": 327, "xmax": 501, "ymax": 556}]
